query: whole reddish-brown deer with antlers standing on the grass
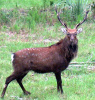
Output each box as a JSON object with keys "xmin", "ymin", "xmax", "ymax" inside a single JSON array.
[{"xmin": 1, "ymin": 8, "xmax": 88, "ymax": 97}]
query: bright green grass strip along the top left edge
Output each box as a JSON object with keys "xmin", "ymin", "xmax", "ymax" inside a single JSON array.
[{"xmin": 0, "ymin": 0, "xmax": 43, "ymax": 9}]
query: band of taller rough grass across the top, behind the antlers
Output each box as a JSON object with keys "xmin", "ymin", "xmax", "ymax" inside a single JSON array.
[{"xmin": 0, "ymin": 0, "xmax": 91, "ymax": 33}]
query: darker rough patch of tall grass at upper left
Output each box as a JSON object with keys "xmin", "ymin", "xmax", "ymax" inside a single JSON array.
[{"xmin": 0, "ymin": 7, "xmax": 50, "ymax": 33}]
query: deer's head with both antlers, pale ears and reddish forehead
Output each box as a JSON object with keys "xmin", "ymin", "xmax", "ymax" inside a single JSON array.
[{"xmin": 55, "ymin": 6, "xmax": 89, "ymax": 42}]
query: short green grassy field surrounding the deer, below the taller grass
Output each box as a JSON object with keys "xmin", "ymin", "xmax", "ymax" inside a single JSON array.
[{"xmin": 0, "ymin": 0, "xmax": 95, "ymax": 100}]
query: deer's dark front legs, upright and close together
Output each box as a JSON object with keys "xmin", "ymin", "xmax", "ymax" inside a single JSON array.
[{"xmin": 55, "ymin": 72, "xmax": 63, "ymax": 94}]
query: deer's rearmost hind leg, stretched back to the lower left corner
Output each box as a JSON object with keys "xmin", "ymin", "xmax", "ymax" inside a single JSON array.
[{"xmin": 1, "ymin": 73, "xmax": 16, "ymax": 98}]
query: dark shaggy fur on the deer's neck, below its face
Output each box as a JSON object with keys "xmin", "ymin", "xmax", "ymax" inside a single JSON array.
[{"xmin": 56, "ymin": 37, "xmax": 78, "ymax": 62}]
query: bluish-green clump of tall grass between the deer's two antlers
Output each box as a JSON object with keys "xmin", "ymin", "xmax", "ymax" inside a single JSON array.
[{"xmin": 56, "ymin": 0, "xmax": 86, "ymax": 26}]
